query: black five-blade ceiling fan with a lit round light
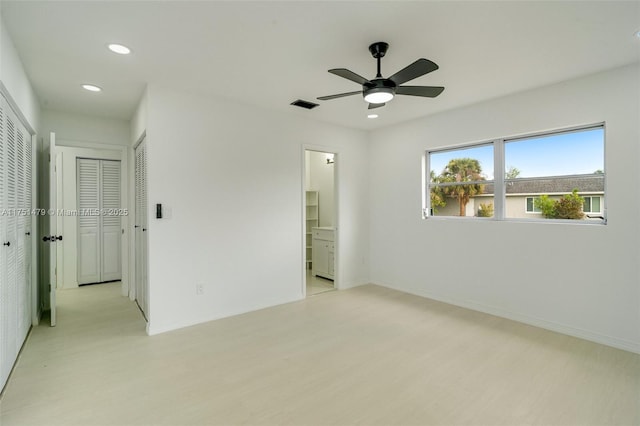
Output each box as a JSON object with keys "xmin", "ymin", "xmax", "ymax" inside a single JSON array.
[{"xmin": 318, "ymin": 41, "xmax": 444, "ymax": 109}]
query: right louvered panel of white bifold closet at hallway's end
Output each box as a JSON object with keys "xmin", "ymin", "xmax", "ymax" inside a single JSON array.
[{"xmin": 100, "ymin": 161, "xmax": 122, "ymax": 281}]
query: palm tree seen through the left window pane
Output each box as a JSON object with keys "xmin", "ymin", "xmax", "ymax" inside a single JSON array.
[{"xmin": 439, "ymin": 158, "xmax": 485, "ymax": 216}]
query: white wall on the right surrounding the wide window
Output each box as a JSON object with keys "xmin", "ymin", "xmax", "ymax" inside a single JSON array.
[{"xmin": 370, "ymin": 66, "xmax": 640, "ymax": 352}]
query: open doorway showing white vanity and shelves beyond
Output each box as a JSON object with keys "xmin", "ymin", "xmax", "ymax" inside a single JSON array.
[{"xmin": 304, "ymin": 150, "xmax": 337, "ymax": 297}]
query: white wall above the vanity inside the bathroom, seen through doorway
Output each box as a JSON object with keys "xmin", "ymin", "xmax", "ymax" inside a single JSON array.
[{"xmin": 308, "ymin": 151, "xmax": 335, "ymax": 226}]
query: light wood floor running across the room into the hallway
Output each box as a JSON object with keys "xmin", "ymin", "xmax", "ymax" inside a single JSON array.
[{"xmin": 0, "ymin": 284, "xmax": 640, "ymax": 426}]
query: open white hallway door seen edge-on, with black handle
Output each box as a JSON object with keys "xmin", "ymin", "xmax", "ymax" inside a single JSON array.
[{"xmin": 44, "ymin": 132, "xmax": 61, "ymax": 327}]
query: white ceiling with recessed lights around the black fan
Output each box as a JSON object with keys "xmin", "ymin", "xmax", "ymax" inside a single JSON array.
[{"xmin": 1, "ymin": 0, "xmax": 640, "ymax": 129}]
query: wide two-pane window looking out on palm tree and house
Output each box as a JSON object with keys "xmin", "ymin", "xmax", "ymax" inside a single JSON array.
[{"xmin": 423, "ymin": 125, "xmax": 606, "ymax": 223}]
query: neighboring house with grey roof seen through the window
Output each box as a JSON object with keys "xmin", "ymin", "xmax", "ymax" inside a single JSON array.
[{"xmin": 435, "ymin": 174, "xmax": 604, "ymax": 219}]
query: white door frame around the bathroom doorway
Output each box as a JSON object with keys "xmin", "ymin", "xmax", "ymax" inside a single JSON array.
[{"xmin": 299, "ymin": 144, "xmax": 342, "ymax": 298}]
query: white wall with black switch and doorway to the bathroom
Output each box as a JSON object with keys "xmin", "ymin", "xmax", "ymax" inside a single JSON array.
[{"xmin": 146, "ymin": 85, "xmax": 369, "ymax": 334}]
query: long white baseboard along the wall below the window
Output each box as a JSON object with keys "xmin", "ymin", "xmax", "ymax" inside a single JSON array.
[{"xmin": 375, "ymin": 283, "xmax": 640, "ymax": 354}]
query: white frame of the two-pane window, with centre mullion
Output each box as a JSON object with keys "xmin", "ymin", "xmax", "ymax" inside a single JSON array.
[{"xmin": 422, "ymin": 122, "xmax": 607, "ymax": 225}]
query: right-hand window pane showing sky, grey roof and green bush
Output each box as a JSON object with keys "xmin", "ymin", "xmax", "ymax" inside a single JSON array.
[{"xmin": 504, "ymin": 127, "xmax": 605, "ymax": 219}]
